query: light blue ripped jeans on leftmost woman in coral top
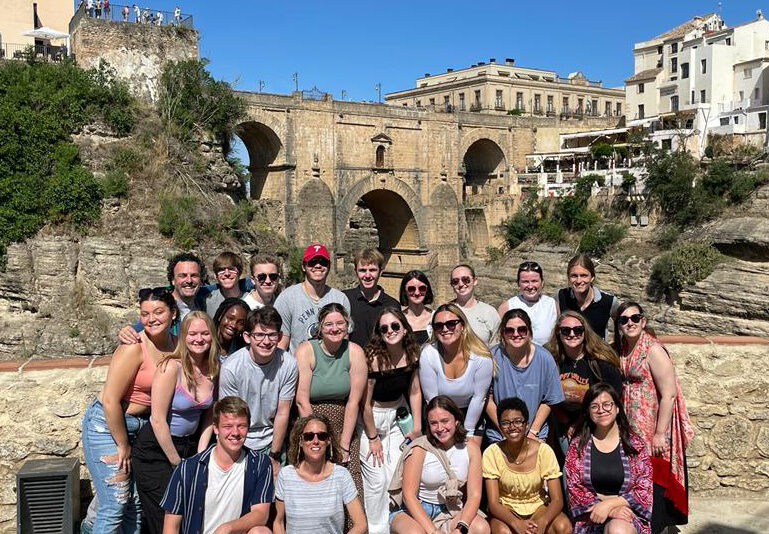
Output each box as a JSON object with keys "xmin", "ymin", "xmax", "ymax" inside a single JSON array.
[{"xmin": 82, "ymin": 399, "xmax": 149, "ymax": 534}]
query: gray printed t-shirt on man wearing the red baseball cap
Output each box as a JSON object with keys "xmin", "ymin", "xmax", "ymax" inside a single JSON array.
[{"xmin": 275, "ymin": 283, "xmax": 350, "ymax": 352}]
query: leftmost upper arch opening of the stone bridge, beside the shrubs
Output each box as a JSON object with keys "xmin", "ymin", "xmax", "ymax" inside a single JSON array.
[{"xmin": 235, "ymin": 121, "xmax": 285, "ymax": 199}]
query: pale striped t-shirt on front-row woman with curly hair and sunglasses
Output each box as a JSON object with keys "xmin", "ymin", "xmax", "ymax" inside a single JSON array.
[{"xmin": 275, "ymin": 464, "xmax": 358, "ymax": 534}]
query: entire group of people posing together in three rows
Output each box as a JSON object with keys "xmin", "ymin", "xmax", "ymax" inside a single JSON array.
[{"xmin": 82, "ymin": 243, "xmax": 693, "ymax": 534}]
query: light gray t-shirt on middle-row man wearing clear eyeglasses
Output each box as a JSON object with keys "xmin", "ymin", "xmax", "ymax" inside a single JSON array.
[{"xmin": 219, "ymin": 347, "xmax": 298, "ymax": 451}]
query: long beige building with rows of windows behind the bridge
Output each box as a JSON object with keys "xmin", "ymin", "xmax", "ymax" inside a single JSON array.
[{"xmin": 385, "ymin": 58, "xmax": 625, "ymax": 118}]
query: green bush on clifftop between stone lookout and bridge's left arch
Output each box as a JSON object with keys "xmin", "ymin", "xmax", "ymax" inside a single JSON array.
[{"xmin": 158, "ymin": 59, "xmax": 245, "ymax": 151}]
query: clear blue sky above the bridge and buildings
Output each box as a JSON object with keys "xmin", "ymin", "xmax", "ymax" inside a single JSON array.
[{"xmin": 126, "ymin": 0, "xmax": 756, "ymax": 100}]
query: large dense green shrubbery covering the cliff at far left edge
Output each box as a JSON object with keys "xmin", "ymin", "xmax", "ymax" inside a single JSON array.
[{"xmin": 0, "ymin": 60, "xmax": 133, "ymax": 266}]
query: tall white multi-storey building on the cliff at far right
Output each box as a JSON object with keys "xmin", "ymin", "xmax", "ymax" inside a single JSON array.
[{"xmin": 625, "ymin": 11, "xmax": 769, "ymax": 156}]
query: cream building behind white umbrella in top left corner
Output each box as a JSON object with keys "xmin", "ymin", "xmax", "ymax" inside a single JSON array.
[{"xmin": 0, "ymin": 0, "xmax": 75, "ymax": 57}]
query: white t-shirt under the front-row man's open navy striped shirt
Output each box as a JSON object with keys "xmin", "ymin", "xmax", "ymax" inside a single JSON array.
[{"xmin": 203, "ymin": 451, "xmax": 246, "ymax": 534}]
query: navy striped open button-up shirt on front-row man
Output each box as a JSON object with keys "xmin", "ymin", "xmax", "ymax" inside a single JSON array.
[{"xmin": 160, "ymin": 445, "xmax": 275, "ymax": 534}]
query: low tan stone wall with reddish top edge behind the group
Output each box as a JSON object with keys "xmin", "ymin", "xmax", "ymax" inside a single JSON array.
[{"xmin": 0, "ymin": 342, "xmax": 769, "ymax": 534}]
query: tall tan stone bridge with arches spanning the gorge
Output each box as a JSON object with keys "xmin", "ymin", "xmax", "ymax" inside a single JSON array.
[{"xmin": 231, "ymin": 91, "xmax": 616, "ymax": 282}]
